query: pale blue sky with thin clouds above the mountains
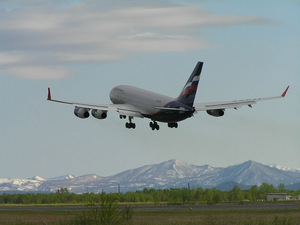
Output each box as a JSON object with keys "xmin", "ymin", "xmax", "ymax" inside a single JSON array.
[{"xmin": 0, "ymin": 0, "xmax": 300, "ymax": 178}]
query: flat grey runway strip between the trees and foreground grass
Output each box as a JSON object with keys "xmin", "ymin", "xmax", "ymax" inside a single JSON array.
[{"xmin": 0, "ymin": 202, "xmax": 300, "ymax": 212}]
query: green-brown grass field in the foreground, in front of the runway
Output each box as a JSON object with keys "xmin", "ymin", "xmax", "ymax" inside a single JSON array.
[{"xmin": 0, "ymin": 209, "xmax": 300, "ymax": 225}]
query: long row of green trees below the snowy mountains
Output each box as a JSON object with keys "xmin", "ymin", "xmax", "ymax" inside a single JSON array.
[{"xmin": 0, "ymin": 183, "xmax": 300, "ymax": 204}]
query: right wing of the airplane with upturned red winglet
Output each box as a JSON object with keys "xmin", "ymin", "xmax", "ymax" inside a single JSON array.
[{"xmin": 194, "ymin": 86, "xmax": 290, "ymax": 111}]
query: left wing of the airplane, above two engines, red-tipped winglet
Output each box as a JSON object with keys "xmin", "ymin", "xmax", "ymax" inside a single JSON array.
[{"xmin": 47, "ymin": 88, "xmax": 144, "ymax": 118}]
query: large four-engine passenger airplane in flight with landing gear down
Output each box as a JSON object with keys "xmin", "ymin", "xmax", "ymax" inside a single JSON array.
[{"xmin": 47, "ymin": 62, "xmax": 289, "ymax": 130}]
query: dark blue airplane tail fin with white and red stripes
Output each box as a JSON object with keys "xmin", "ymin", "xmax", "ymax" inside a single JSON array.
[{"xmin": 177, "ymin": 62, "xmax": 203, "ymax": 107}]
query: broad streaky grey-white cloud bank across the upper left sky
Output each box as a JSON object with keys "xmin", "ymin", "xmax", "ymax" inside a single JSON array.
[{"xmin": 0, "ymin": 1, "xmax": 274, "ymax": 79}]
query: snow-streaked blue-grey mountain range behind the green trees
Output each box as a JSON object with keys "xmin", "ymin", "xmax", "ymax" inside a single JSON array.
[{"xmin": 0, "ymin": 160, "xmax": 300, "ymax": 193}]
